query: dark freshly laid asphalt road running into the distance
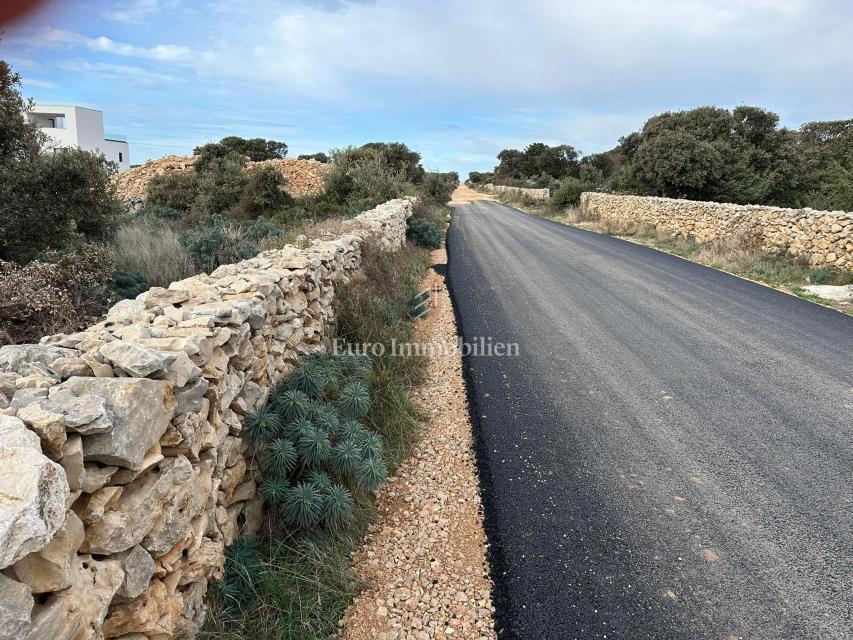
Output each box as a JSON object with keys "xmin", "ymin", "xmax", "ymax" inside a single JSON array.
[{"xmin": 448, "ymin": 202, "xmax": 853, "ymax": 640}]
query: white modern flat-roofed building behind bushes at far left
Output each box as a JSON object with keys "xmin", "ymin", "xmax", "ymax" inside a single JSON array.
[{"xmin": 27, "ymin": 104, "xmax": 130, "ymax": 171}]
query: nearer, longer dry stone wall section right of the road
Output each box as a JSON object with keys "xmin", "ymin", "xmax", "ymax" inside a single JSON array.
[{"xmin": 580, "ymin": 192, "xmax": 853, "ymax": 270}]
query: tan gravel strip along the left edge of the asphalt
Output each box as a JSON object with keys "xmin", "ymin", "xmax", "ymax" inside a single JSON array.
[{"xmin": 338, "ymin": 249, "xmax": 496, "ymax": 640}]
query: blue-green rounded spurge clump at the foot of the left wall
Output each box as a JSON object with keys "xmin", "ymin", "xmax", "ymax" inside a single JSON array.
[{"xmin": 245, "ymin": 356, "xmax": 387, "ymax": 529}]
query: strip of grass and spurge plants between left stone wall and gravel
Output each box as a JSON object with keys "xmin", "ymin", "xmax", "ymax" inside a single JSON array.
[{"xmin": 200, "ymin": 239, "xmax": 429, "ymax": 640}]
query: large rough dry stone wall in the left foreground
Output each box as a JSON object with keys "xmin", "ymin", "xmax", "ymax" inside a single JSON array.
[{"xmin": 0, "ymin": 199, "xmax": 412, "ymax": 640}]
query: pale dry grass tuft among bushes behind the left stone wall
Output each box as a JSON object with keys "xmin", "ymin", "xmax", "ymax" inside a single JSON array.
[{"xmin": 110, "ymin": 221, "xmax": 196, "ymax": 287}]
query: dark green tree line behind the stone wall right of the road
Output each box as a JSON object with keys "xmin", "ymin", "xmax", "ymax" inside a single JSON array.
[{"xmin": 469, "ymin": 106, "xmax": 853, "ymax": 210}]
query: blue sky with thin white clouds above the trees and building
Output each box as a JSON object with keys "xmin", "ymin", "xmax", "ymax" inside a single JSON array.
[{"xmin": 5, "ymin": 0, "xmax": 853, "ymax": 174}]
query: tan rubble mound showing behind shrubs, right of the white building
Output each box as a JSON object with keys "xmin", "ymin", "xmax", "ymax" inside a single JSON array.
[{"xmin": 114, "ymin": 156, "xmax": 332, "ymax": 202}]
